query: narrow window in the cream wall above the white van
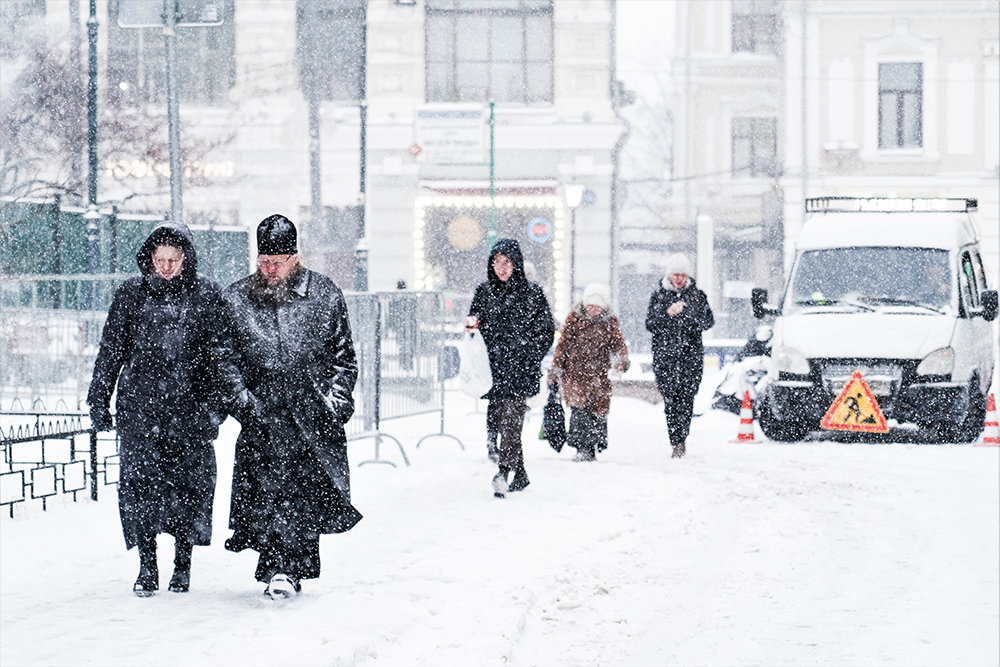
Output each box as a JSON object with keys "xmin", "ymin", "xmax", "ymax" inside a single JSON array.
[{"xmin": 878, "ymin": 63, "xmax": 923, "ymax": 148}]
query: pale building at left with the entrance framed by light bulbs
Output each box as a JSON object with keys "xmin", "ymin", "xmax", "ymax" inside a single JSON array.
[{"xmin": 5, "ymin": 0, "xmax": 623, "ymax": 314}]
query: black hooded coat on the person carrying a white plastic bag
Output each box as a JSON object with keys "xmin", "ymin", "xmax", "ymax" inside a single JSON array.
[{"xmin": 469, "ymin": 239, "xmax": 555, "ymax": 398}]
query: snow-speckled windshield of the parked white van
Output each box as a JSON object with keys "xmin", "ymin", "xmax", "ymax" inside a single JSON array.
[{"xmin": 786, "ymin": 247, "xmax": 954, "ymax": 313}]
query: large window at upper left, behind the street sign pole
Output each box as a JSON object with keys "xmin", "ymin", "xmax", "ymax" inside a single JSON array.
[{"xmin": 108, "ymin": 0, "xmax": 236, "ymax": 105}]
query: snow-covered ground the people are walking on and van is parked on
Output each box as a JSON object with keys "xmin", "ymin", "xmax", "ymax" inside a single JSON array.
[{"xmin": 0, "ymin": 386, "xmax": 1000, "ymax": 666}]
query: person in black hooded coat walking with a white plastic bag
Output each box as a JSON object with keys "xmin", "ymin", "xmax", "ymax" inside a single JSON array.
[{"xmin": 466, "ymin": 239, "xmax": 555, "ymax": 498}]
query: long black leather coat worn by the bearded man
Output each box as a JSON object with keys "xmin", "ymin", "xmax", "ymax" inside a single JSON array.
[{"xmin": 224, "ymin": 269, "xmax": 361, "ymax": 551}]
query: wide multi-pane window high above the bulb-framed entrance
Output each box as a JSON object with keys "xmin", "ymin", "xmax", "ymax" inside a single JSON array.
[{"xmin": 426, "ymin": 0, "xmax": 553, "ymax": 104}]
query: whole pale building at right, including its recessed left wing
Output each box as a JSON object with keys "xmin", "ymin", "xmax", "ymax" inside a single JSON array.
[{"xmin": 622, "ymin": 0, "xmax": 1000, "ymax": 338}]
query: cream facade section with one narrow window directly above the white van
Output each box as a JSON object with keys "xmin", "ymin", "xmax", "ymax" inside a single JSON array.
[{"xmin": 781, "ymin": 0, "xmax": 1000, "ymax": 287}]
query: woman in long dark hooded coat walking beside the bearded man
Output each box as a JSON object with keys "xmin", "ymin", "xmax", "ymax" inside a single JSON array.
[{"xmin": 87, "ymin": 223, "xmax": 225, "ymax": 597}]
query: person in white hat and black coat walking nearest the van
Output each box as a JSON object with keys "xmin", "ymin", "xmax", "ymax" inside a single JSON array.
[{"xmin": 646, "ymin": 254, "xmax": 715, "ymax": 458}]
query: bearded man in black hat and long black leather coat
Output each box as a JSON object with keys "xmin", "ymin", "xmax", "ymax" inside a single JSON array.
[{"xmin": 224, "ymin": 215, "xmax": 361, "ymax": 598}]
